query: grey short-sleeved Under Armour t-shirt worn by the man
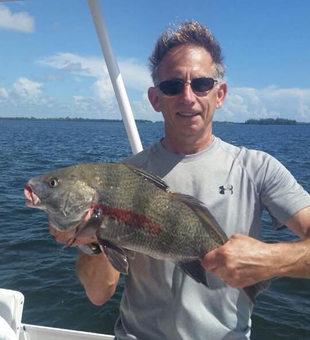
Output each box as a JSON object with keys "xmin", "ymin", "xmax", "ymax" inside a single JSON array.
[{"xmin": 115, "ymin": 138, "xmax": 310, "ymax": 340}]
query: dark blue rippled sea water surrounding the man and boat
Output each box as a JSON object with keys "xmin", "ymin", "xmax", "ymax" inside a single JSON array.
[{"xmin": 0, "ymin": 120, "xmax": 310, "ymax": 340}]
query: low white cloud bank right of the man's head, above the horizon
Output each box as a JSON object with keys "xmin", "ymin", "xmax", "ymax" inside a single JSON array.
[{"xmin": 215, "ymin": 86, "xmax": 310, "ymax": 122}]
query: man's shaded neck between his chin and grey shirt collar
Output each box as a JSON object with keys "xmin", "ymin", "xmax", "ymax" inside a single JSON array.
[{"xmin": 162, "ymin": 131, "xmax": 214, "ymax": 155}]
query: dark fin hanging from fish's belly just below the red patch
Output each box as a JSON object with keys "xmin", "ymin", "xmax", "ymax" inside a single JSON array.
[{"xmin": 98, "ymin": 239, "xmax": 129, "ymax": 275}]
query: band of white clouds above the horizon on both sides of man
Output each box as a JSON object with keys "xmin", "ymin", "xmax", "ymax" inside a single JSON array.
[{"xmin": 0, "ymin": 78, "xmax": 310, "ymax": 122}]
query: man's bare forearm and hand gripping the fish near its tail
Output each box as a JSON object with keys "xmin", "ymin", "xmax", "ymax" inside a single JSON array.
[{"xmin": 201, "ymin": 206, "xmax": 310, "ymax": 288}]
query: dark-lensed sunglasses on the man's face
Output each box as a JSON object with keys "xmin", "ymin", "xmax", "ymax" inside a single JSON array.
[{"xmin": 155, "ymin": 77, "xmax": 218, "ymax": 96}]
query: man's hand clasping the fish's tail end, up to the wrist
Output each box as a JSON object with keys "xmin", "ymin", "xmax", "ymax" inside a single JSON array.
[{"xmin": 201, "ymin": 234, "xmax": 280, "ymax": 288}]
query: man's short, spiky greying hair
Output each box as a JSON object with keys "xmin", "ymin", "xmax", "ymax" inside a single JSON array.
[{"xmin": 149, "ymin": 21, "xmax": 225, "ymax": 84}]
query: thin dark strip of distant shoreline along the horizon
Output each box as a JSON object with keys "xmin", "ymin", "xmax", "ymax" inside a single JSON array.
[{"xmin": 0, "ymin": 117, "xmax": 310, "ymax": 125}]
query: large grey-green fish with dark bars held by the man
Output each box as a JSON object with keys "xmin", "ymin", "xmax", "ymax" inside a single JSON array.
[{"xmin": 24, "ymin": 163, "xmax": 266, "ymax": 303}]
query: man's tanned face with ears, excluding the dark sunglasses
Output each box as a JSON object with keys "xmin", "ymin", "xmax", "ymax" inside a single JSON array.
[{"xmin": 149, "ymin": 46, "xmax": 226, "ymax": 151}]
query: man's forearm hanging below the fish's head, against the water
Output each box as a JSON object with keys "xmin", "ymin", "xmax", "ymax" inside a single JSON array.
[{"xmin": 76, "ymin": 251, "xmax": 119, "ymax": 305}]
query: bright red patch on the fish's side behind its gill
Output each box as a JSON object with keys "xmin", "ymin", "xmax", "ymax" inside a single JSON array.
[{"xmin": 99, "ymin": 205, "xmax": 162, "ymax": 235}]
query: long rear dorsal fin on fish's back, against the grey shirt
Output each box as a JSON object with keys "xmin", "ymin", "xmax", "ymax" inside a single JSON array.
[{"xmin": 171, "ymin": 193, "xmax": 228, "ymax": 244}]
